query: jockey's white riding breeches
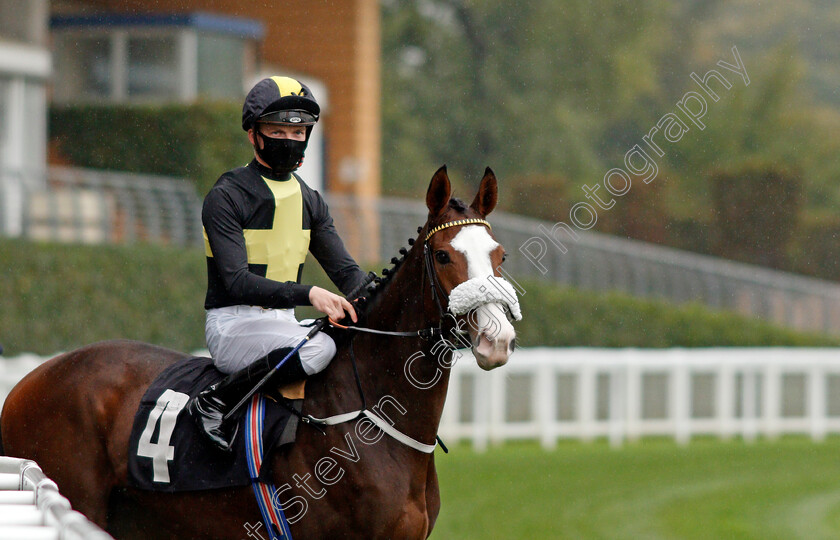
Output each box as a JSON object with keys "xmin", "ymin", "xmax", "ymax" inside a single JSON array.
[{"xmin": 204, "ymin": 306, "xmax": 335, "ymax": 375}]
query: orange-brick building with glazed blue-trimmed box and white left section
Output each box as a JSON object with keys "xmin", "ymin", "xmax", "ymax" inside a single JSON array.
[{"xmin": 0, "ymin": 0, "xmax": 381, "ymax": 258}]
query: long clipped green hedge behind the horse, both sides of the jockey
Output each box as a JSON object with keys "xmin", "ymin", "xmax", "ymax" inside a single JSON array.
[{"xmin": 0, "ymin": 239, "xmax": 840, "ymax": 355}]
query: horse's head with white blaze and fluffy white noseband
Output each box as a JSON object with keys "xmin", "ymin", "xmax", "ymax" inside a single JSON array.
[{"xmin": 420, "ymin": 166, "xmax": 521, "ymax": 370}]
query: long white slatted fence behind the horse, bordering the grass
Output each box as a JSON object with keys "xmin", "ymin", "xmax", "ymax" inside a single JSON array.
[{"xmin": 0, "ymin": 348, "xmax": 840, "ymax": 449}]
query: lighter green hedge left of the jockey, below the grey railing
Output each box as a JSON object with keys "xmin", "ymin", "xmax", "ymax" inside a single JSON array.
[{"xmin": 0, "ymin": 240, "xmax": 206, "ymax": 355}]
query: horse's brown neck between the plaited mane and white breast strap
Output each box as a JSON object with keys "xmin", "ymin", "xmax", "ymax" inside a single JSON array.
[{"xmin": 316, "ymin": 249, "xmax": 449, "ymax": 444}]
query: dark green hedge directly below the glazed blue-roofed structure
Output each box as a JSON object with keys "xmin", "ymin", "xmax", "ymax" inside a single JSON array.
[{"xmin": 49, "ymin": 103, "xmax": 253, "ymax": 194}]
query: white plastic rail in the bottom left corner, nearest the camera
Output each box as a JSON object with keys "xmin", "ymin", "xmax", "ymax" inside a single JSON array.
[{"xmin": 0, "ymin": 457, "xmax": 113, "ymax": 540}]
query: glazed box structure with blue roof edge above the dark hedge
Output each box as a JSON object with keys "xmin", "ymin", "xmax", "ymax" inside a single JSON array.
[{"xmin": 50, "ymin": 13, "xmax": 262, "ymax": 103}]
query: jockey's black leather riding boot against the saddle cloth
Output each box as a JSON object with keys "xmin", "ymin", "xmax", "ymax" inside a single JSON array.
[{"xmin": 187, "ymin": 347, "xmax": 306, "ymax": 452}]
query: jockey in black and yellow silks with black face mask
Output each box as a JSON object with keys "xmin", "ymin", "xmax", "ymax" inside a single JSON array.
[{"xmin": 187, "ymin": 77, "xmax": 365, "ymax": 451}]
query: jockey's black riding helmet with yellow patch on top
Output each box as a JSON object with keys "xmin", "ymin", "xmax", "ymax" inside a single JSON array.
[{"xmin": 242, "ymin": 76, "xmax": 321, "ymax": 140}]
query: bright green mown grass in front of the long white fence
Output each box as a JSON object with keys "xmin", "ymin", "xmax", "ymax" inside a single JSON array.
[{"xmin": 432, "ymin": 438, "xmax": 840, "ymax": 540}]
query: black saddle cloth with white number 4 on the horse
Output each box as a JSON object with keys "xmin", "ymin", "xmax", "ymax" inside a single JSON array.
[{"xmin": 128, "ymin": 357, "xmax": 303, "ymax": 492}]
